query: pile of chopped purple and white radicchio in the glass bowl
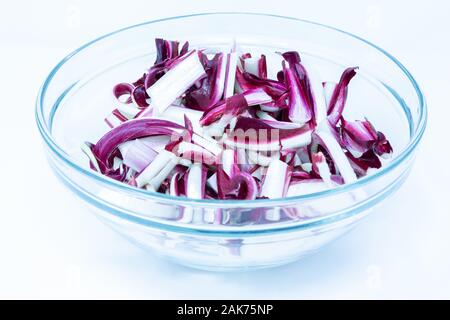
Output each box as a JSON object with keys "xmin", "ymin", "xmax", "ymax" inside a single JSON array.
[{"xmin": 82, "ymin": 39, "xmax": 392, "ymax": 200}]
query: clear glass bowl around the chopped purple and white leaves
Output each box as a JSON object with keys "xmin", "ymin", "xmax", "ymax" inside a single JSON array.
[{"xmin": 36, "ymin": 13, "xmax": 426, "ymax": 270}]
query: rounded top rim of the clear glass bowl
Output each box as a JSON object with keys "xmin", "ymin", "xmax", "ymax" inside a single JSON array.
[{"xmin": 35, "ymin": 12, "xmax": 427, "ymax": 209}]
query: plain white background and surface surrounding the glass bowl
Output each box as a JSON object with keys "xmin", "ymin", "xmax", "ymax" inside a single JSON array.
[{"xmin": 0, "ymin": 0, "xmax": 450, "ymax": 299}]
